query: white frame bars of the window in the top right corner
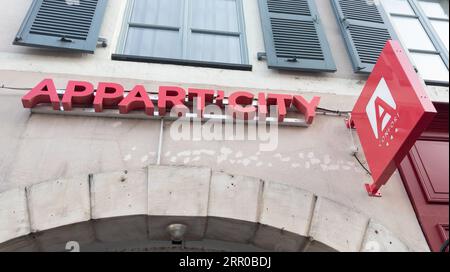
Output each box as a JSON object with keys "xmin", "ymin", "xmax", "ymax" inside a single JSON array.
[{"xmin": 380, "ymin": 0, "xmax": 449, "ymax": 86}]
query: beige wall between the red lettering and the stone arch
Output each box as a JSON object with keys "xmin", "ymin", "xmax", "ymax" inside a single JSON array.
[{"xmin": 0, "ymin": 85, "xmax": 427, "ymax": 250}]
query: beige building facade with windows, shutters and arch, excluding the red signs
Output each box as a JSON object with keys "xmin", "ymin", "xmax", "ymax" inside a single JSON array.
[{"xmin": 0, "ymin": 0, "xmax": 449, "ymax": 251}]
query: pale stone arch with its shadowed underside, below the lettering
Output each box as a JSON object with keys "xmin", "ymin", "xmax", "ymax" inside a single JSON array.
[{"xmin": 0, "ymin": 165, "xmax": 409, "ymax": 251}]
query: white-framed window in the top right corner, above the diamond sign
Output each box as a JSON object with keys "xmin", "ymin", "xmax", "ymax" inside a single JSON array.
[{"xmin": 382, "ymin": 0, "xmax": 449, "ymax": 84}]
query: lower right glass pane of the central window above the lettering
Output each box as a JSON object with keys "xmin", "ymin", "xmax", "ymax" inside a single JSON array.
[{"xmin": 189, "ymin": 33, "xmax": 241, "ymax": 63}]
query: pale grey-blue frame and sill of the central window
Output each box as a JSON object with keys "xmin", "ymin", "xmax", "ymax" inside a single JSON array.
[{"xmin": 111, "ymin": 0, "xmax": 252, "ymax": 71}]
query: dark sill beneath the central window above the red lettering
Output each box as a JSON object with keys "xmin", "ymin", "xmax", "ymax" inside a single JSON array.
[{"xmin": 111, "ymin": 54, "xmax": 252, "ymax": 71}]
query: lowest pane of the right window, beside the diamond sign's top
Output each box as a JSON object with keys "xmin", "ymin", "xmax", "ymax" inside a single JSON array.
[{"xmin": 411, "ymin": 53, "xmax": 448, "ymax": 82}]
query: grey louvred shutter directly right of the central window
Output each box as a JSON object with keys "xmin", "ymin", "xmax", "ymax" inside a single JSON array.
[{"xmin": 259, "ymin": 0, "xmax": 336, "ymax": 72}]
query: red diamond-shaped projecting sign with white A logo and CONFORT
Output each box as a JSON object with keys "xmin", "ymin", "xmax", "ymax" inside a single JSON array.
[{"xmin": 352, "ymin": 41, "xmax": 436, "ymax": 196}]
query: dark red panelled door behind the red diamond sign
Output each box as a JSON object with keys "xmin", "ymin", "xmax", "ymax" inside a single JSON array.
[{"xmin": 399, "ymin": 104, "xmax": 449, "ymax": 251}]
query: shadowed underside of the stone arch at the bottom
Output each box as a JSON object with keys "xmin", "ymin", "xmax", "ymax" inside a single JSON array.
[{"xmin": 0, "ymin": 215, "xmax": 335, "ymax": 252}]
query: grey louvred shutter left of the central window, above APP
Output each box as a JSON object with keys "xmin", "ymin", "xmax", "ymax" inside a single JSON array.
[{"xmin": 13, "ymin": 0, "xmax": 107, "ymax": 53}]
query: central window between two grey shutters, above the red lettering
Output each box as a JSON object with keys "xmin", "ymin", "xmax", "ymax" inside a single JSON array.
[{"xmin": 113, "ymin": 0, "xmax": 251, "ymax": 70}]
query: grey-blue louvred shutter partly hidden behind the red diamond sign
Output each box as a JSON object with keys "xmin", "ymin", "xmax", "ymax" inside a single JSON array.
[{"xmin": 331, "ymin": 0, "xmax": 394, "ymax": 73}]
